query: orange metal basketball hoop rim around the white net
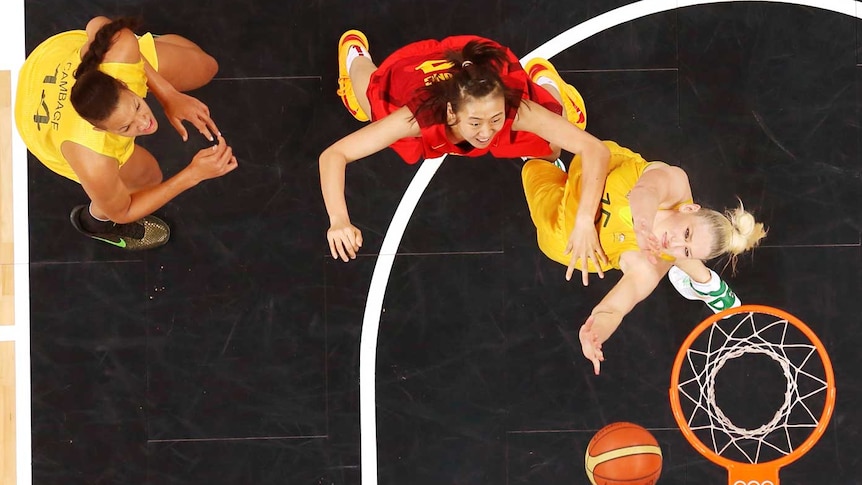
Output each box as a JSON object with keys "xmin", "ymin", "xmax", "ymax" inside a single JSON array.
[{"xmin": 669, "ymin": 305, "xmax": 836, "ymax": 485}]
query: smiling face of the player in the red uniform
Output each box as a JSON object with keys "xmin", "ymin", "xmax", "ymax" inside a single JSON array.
[{"xmin": 452, "ymin": 93, "xmax": 506, "ymax": 148}]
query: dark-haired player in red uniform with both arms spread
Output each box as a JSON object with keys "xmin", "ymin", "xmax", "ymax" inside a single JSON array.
[{"xmin": 320, "ymin": 30, "xmax": 610, "ymax": 284}]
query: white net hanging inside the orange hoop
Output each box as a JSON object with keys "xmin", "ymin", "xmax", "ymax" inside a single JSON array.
[{"xmin": 677, "ymin": 312, "xmax": 827, "ymax": 464}]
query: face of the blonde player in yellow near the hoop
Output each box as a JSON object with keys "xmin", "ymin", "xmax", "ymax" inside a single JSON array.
[{"xmin": 653, "ymin": 205, "xmax": 714, "ymax": 260}]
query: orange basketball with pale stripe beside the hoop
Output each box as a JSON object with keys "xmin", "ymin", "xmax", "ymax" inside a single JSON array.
[{"xmin": 585, "ymin": 423, "xmax": 661, "ymax": 485}]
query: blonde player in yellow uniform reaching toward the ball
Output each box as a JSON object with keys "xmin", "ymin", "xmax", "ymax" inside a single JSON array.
[{"xmin": 522, "ymin": 141, "xmax": 766, "ymax": 374}]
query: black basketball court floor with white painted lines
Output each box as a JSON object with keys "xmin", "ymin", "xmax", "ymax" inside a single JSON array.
[{"xmin": 0, "ymin": 0, "xmax": 862, "ymax": 485}]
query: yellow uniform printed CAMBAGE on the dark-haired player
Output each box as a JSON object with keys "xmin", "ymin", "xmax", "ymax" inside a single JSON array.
[{"xmin": 15, "ymin": 30, "xmax": 158, "ymax": 182}]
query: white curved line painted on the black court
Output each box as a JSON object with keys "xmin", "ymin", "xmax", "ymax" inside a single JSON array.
[{"xmin": 359, "ymin": 0, "xmax": 862, "ymax": 485}]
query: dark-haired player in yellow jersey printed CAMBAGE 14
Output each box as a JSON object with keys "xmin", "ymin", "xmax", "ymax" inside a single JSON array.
[{"xmin": 15, "ymin": 17, "xmax": 236, "ymax": 249}]
